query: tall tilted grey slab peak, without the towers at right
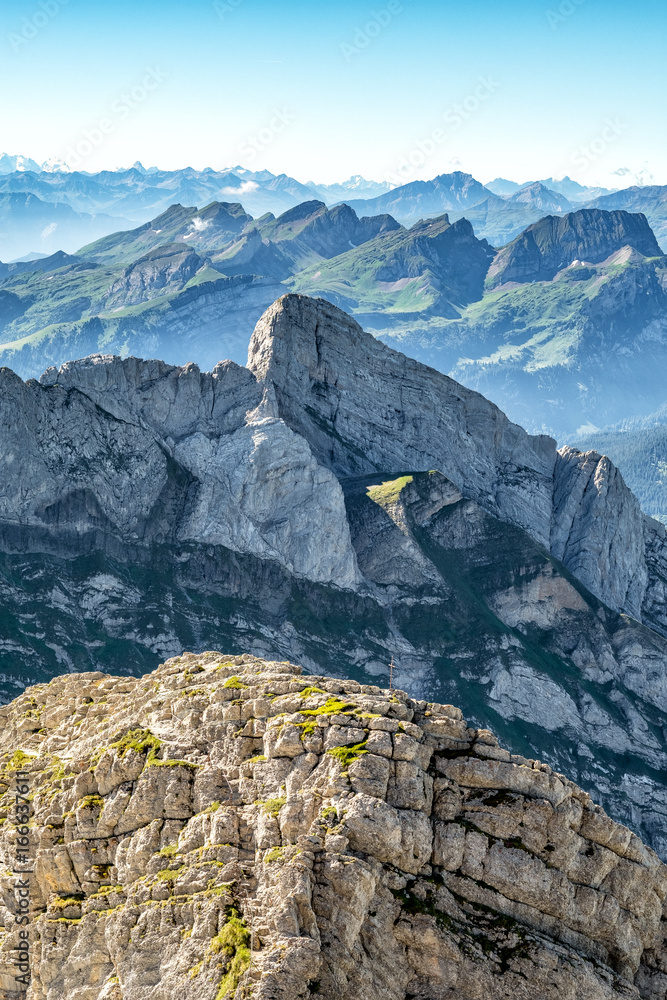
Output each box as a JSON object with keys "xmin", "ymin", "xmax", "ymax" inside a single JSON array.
[{"xmin": 248, "ymin": 295, "xmax": 556, "ymax": 541}]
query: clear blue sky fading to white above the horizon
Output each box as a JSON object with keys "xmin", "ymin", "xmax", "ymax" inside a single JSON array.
[{"xmin": 0, "ymin": 0, "xmax": 667, "ymax": 187}]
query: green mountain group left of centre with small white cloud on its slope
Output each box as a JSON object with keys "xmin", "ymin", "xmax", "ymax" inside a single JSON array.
[{"xmin": 0, "ymin": 201, "xmax": 401, "ymax": 376}]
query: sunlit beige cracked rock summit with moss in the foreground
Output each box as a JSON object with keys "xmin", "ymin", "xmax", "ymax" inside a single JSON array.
[{"xmin": 0, "ymin": 653, "xmax": 667, "ymax": 1000}]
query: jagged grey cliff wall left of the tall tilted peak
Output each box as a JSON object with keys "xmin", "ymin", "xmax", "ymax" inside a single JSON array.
[{"xmin": 5, "ymin": 357, "xmax": 357, "ymax": 586}]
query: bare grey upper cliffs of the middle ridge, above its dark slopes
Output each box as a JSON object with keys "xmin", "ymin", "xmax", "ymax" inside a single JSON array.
[{"xmin": 22, "ymin": 295, "xmax": 667, "ymax": 633}]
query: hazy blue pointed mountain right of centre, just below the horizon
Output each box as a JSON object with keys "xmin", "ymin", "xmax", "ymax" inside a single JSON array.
[{"xmin": 345, "ymin": 171, "xmax": 489, "ymax": 223}]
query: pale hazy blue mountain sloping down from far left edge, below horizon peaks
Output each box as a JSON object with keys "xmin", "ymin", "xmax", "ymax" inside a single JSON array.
[{"xmin": 0, "ymin": 192, "xmax": 132, "ymax": 260}]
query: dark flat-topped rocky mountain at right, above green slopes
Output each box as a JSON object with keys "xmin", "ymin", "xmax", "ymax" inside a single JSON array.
[{"xmin": 488, "ymin": 209, "xmax": 662, "ymax": 288}]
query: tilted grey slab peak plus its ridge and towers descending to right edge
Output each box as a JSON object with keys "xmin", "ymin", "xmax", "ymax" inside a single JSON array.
[{"xmin": 248, "ymin": 296, "xmax": 667, "ymax": 634}]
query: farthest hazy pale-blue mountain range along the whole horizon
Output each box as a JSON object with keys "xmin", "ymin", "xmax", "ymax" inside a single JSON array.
[{"xmin": 5, "ymin": 155, "xmax": 667, "ymax": 260}]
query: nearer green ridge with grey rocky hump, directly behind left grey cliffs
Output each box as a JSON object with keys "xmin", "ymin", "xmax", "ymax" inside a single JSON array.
[{"xmin": 0, "ymin": 262, "xmax": 285, "ymax": 378}]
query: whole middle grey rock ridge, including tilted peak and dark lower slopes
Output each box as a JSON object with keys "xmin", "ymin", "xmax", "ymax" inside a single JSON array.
[{"xmin": 0, "ymin": 295, "xmax": 667, "ymax": 864}]
